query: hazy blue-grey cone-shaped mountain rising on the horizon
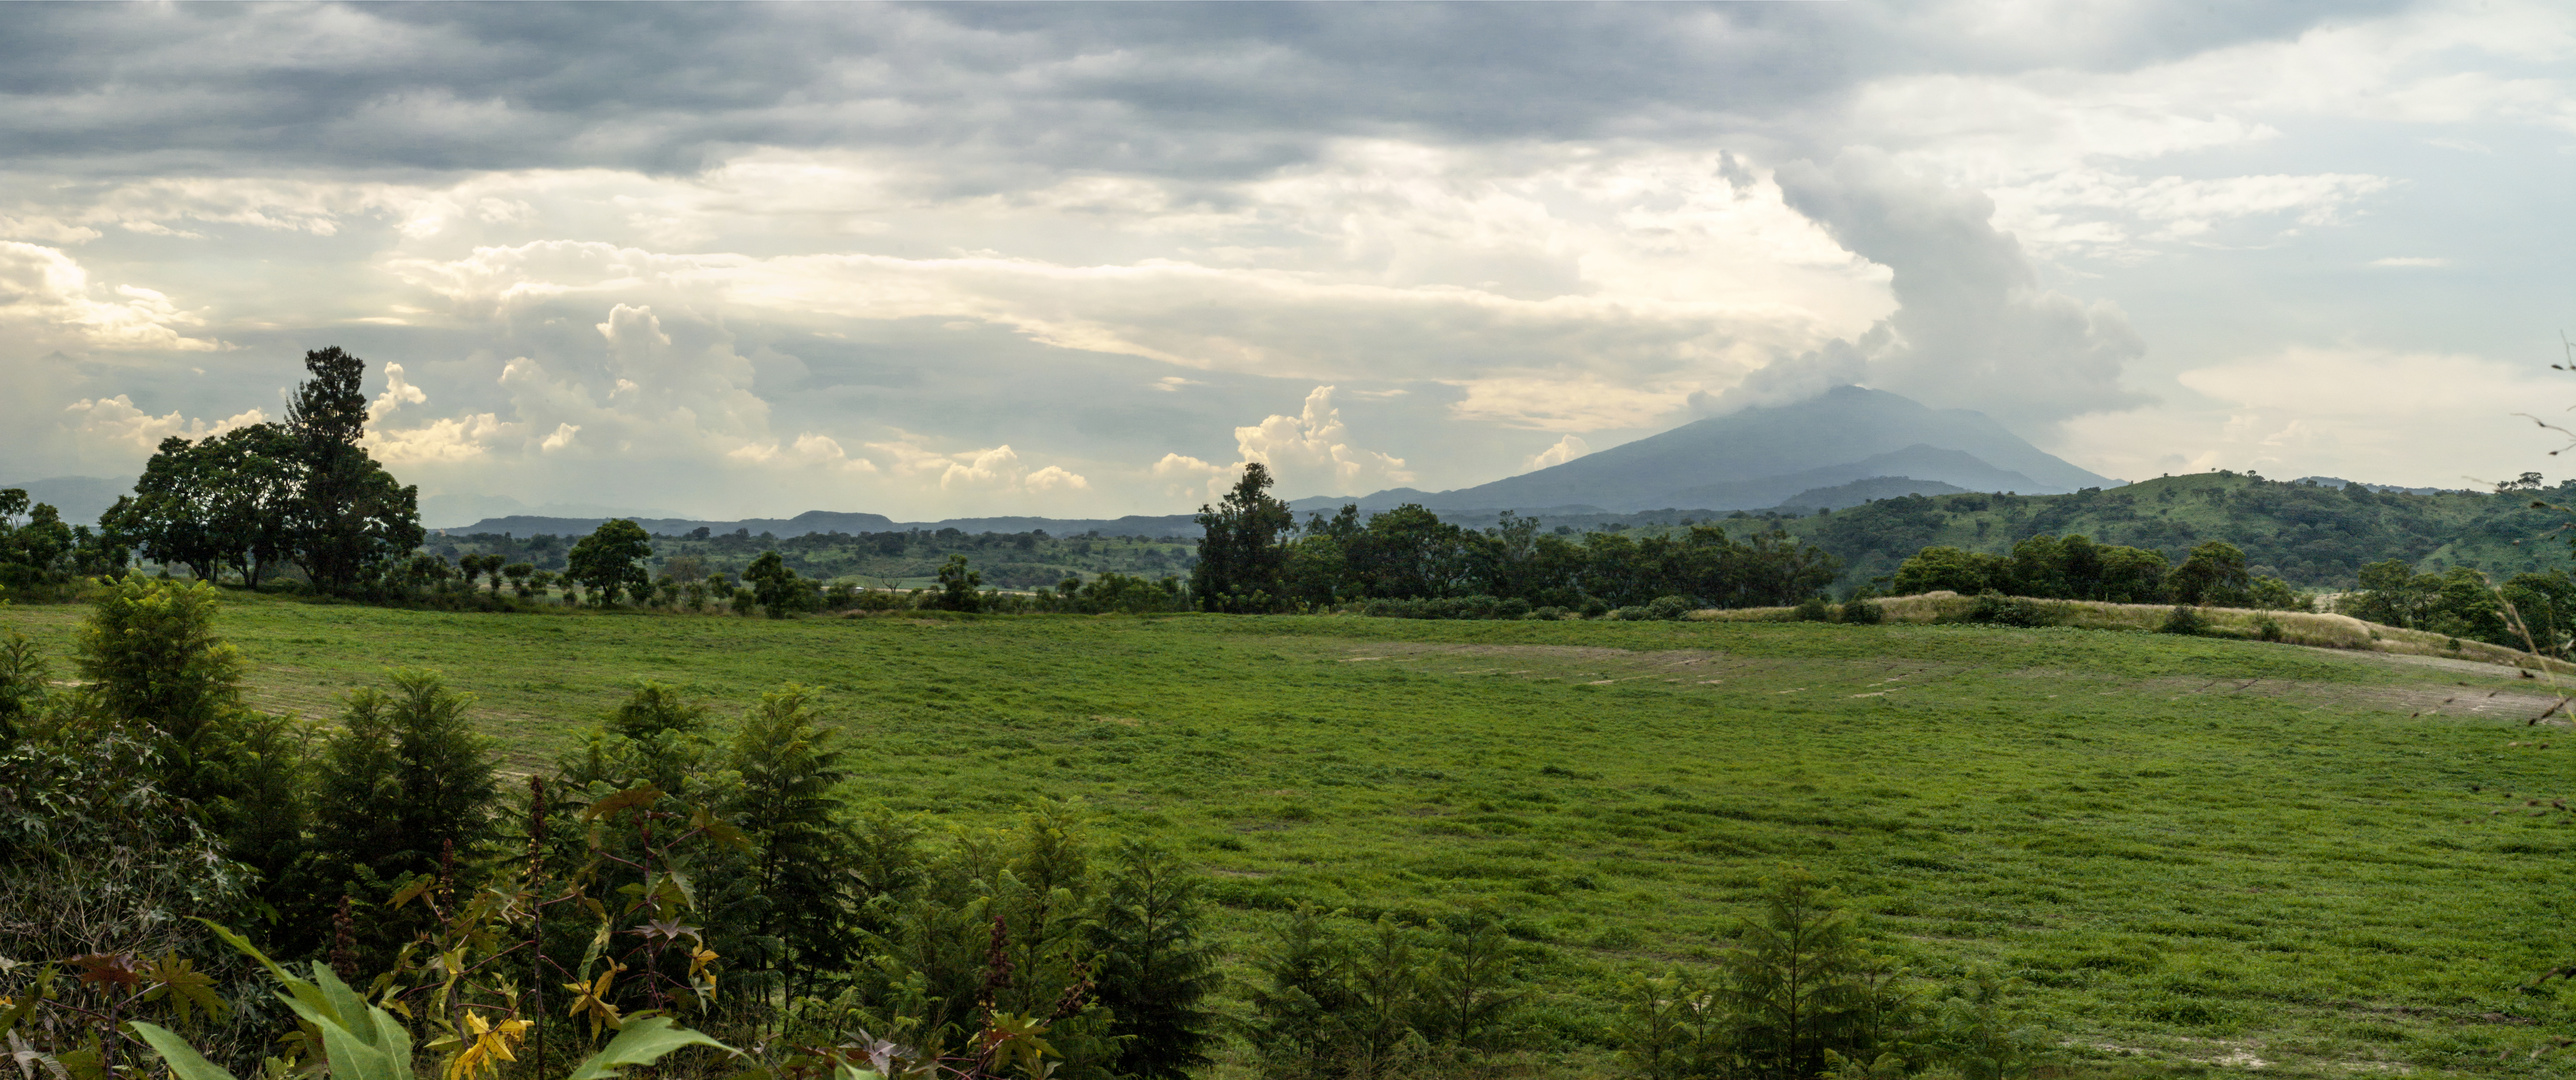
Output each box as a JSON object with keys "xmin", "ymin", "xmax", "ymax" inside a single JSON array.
[{"xmin": 1296, "ymin": 387, "xmax": 2117, "ymax": 513}]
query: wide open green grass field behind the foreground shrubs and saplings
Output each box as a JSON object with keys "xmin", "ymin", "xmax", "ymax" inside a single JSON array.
[{"xmin": 0, "ymin": 598, "xmax": 2576, "ymax": 1075}]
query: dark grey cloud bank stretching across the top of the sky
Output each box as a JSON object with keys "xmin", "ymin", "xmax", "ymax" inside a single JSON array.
[{"xmin": 0, "ymin": 5, "xmax": 2390, "ymax": 178}]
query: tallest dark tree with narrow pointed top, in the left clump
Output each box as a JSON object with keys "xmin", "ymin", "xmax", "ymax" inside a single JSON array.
[{"xmin": 286, "ymin": 345, "xmax": 422, "ymax": 593}]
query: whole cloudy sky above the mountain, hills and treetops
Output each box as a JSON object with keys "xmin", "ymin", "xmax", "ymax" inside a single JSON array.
[{"xmin": 0, "ymin": 0, "xmax": 2576, "ymax": 523}]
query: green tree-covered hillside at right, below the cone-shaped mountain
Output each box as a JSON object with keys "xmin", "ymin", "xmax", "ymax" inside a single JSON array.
[{"xmin": 1780, "ymin": 472, "xmax": 2576, "ymax": 588}]
